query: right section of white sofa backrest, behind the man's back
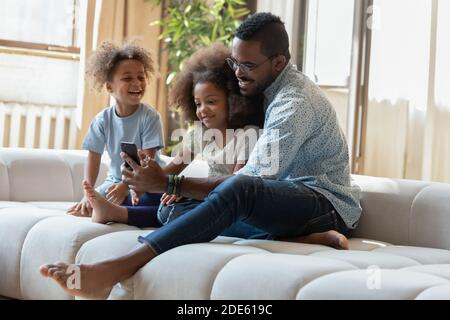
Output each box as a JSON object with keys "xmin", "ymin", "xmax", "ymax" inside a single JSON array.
[{"xmin": 353, "ymin": 175, "xmax": 450, "ymax": 249}]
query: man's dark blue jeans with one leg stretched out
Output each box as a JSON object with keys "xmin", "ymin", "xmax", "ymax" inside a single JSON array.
[{"xmin": 138, "ymin": 175, "xmax": 349, "ymax": 254}]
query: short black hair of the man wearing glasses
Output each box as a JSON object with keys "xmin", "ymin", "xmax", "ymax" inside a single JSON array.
[{"xmin": 234, "ymin": 12, "xmax": 291, "ymax": 60}]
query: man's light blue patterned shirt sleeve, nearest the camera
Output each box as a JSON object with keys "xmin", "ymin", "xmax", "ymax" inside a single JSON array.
[{"xmin": 236, "ymin": 95, "xmax": 317, "ymax": 179}]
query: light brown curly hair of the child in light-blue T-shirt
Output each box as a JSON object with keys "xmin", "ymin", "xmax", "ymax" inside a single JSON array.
[{"xmin": 86, "ymin": 41, "xmax": 154, "ymax": 91}]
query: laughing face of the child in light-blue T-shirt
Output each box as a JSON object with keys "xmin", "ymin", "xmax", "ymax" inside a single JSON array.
[{"xmin": 106, "ymin": 59, "xmax": 147, "ymax": 108}]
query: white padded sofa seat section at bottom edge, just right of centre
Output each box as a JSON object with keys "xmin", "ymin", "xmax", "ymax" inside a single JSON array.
[{"xmin": 211, "ymin": 253, "xmax": 356, "ymax": 300}]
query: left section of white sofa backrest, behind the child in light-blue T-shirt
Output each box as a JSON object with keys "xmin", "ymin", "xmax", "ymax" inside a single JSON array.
[{"xmin": 0, "ymin": 148, "xmax": 108, "ymax": 201}]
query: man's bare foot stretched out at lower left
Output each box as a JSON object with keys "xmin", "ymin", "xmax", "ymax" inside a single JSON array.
[{"xmin": 39, "ymin": 263, "xmax": 118, "ymax": 299}]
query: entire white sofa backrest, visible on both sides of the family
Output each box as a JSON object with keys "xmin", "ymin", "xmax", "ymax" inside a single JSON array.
[{"xmin": 0, "ymin": 148, "xmax": 450, "ymax": 249}]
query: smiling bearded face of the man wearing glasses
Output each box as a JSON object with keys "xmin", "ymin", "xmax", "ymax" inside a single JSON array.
[{"xmin": 231, "ymin": 37, "xmax": 280, "ymax": 96}]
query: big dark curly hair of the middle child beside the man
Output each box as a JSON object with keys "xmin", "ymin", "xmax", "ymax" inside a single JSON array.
[{"xmin": 169, "ymin": 42, "xmax": 264, "ymax": 129}]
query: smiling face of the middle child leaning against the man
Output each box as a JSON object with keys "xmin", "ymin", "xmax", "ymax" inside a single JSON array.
[{"xmin": 194, "ymin": 82, "xmax": 228, "ymax": 130}]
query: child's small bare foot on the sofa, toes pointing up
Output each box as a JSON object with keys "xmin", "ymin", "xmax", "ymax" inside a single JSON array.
[{"xmin": 83, "ymin": 181, "xmax": 128, "ymax": 223}]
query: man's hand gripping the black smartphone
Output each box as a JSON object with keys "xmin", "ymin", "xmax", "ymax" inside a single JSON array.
[{"xmin": 120, "ymin": 152, "xmax": 167, "ymax": 193}]
